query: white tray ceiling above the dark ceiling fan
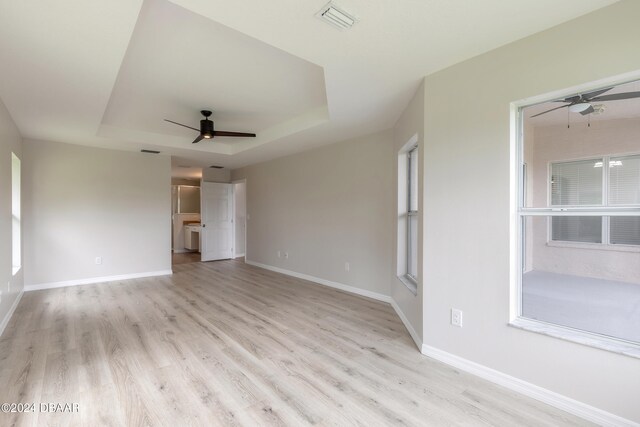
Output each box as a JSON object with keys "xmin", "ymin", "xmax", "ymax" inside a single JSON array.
[{"xmin": 0, "ymin": 0, "xmax": 614, "ymax": 172}]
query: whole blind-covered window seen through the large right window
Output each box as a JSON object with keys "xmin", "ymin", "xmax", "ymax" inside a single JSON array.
[{"xmin": 550, "ymin": 155, "xmax": 640, "ymax": 245}]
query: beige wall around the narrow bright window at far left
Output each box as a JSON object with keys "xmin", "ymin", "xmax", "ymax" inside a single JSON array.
[{"xmin": 0, "ymin": 101, "xmax": 26, "ymax": 332}]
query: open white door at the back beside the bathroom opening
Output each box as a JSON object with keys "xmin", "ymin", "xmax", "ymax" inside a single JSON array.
[{"xmin": 200, "ymin": 182, "xmax": 233, "ymax": 261}]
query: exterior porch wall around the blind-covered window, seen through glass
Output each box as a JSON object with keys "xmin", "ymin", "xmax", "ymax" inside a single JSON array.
[{"xmin": 529, "ymin": 118, "xmax": 640, "ymax": 283}]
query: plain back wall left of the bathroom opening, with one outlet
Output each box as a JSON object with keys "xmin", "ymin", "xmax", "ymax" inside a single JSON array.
[{"xmin": 23, "ymin": 140, "xmax": 171, "ymax": 286}]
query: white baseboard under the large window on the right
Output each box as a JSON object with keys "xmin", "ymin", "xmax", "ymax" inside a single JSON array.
[{"xmin": 422, "ymin": 344, "xmax": 640, "ymax": 427}]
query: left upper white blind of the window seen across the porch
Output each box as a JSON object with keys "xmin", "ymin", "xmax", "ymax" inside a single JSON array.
[{"xmin": 551, "ymin": 159, "xmax": 603, "ymax": 206}]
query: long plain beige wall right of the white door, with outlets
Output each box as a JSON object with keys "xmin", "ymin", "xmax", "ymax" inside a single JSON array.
[{"xmin": 232, "ymin": 132, "xmax": 395, "ymax": 296}]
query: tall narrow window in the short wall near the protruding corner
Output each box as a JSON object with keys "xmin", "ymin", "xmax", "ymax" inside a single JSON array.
[{"xmin": 407, "ymin": 147, "xmax": 418, "ymax": 282}]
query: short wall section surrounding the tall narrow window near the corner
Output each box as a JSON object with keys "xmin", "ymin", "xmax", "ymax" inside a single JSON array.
[{"xmin": 389, "ymin": 83, "xmax": 424, "ymax": 345}]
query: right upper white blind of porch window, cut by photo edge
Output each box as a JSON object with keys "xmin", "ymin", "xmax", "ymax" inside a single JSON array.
[{"xmin": 609, "ymin": 156, "xmax": 640, "ymax": 205}]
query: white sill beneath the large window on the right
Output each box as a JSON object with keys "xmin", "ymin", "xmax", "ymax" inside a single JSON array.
[{"xmin": 509, "ymin": 317, "xmax": 640, "ymax": 359}]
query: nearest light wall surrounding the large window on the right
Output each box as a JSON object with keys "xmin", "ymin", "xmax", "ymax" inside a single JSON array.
[{"xmin": 423, "ymin": 1, "xmax": 640, "ymax": 422}]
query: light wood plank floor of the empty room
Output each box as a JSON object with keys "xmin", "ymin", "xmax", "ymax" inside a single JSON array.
[{"xmin": 0, "ymin": 261, "xmax": 587, "ymax": 426}]
